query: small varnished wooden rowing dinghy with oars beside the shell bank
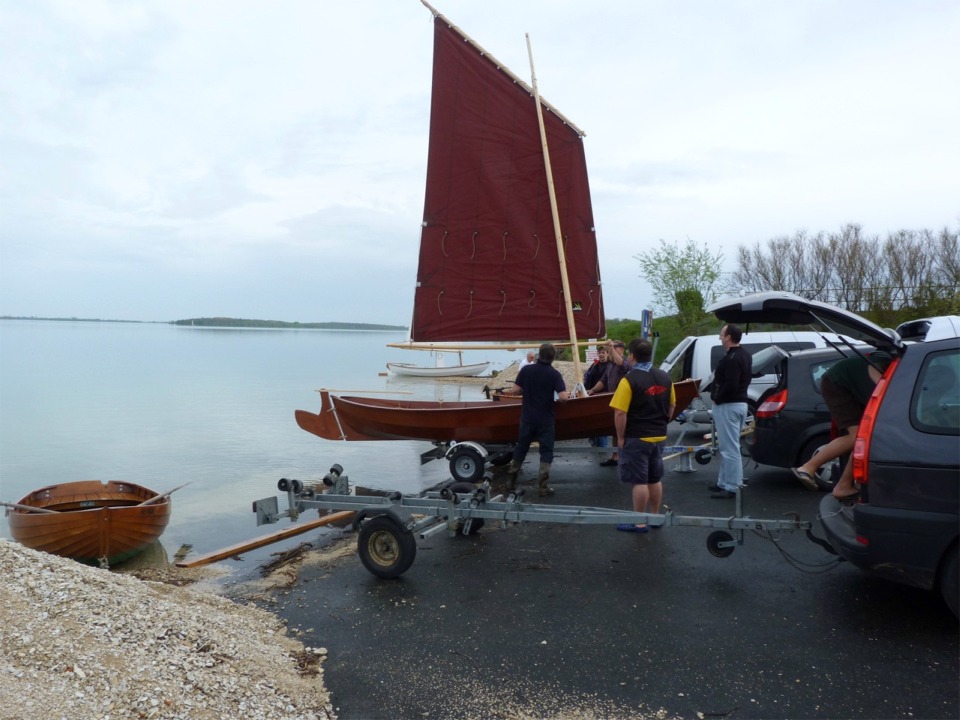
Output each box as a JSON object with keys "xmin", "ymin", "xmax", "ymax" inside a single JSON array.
[{"xmin": 5, "ymin": 480, "xmax": 170, "ymax": 566}]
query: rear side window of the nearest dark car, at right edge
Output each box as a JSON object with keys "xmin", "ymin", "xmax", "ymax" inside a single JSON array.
[{"xmin": 910, "ymin": 350, "xmax": 960, "ymax": 435}]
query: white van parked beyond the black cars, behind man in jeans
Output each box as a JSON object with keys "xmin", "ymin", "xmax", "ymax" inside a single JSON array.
[{"xmin": 660, "ymin": 330, "xmax": 844, "ymax": 407}]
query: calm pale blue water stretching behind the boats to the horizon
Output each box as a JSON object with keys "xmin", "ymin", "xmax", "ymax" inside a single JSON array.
[{"xmin": 0, "ymin": 320, "xmax": 520, "ymax": 580}]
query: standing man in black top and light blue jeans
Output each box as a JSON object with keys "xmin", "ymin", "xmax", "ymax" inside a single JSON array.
[{"xmin": 710, "ymin": 324, "xmax": 753, "ymax": 500}]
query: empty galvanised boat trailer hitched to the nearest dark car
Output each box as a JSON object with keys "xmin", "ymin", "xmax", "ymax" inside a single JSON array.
[{"xmin": 253, "ymin": 465, "xmax": 811, "ymax": 578}]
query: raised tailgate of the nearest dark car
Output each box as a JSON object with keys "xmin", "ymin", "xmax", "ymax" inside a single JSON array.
[{"xmin": 707, "ymin": 291, "xmax": 903, "ymax": 352}]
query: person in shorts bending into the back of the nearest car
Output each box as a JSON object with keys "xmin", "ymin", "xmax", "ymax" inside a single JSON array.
[{"xmin": 792, "ymin": 352, "xmax": 891, "ymax": 500}]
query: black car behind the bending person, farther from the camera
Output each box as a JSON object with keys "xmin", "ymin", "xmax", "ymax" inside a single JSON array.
[{"xmin": 744, "ymin": 345, "xmax": 873, "ymax": 491}]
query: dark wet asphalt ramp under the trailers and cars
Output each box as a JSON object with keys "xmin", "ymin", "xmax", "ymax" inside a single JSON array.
[{"xmin": 262, "ymin": 422, "xmax": 960, "ymax": 720}]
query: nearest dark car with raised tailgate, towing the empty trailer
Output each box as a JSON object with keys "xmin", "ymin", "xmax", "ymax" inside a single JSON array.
[{"xmin": 710, "ymin": 293, "xmax": 960, "ymax": 616}]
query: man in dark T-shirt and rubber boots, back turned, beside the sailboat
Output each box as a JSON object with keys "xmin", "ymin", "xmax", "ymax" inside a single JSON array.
[{"xmin": 504, "ymin": 343, "xmax": 569, "ymax": 497}]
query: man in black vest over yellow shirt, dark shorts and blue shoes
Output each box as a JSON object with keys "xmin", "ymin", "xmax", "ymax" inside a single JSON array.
[{"xmin": 610, "ymin": 338, "xmax": 676, "ymax": 533}]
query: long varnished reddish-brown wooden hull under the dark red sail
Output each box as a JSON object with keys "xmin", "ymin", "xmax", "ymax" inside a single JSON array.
[{"xmin": 295, "ymin": 380, "xmax": 698, "ymax": 443}]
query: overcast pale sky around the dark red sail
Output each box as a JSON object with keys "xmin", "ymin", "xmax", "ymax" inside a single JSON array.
[{"xmin": 0, "ymin": 0, "xmax": 960, "ymax": 325}]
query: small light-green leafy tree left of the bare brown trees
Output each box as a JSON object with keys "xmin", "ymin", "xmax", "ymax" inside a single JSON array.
[{"xmin": 634, "ymin": 238, "xmax": 723, "ymax": 328}]
